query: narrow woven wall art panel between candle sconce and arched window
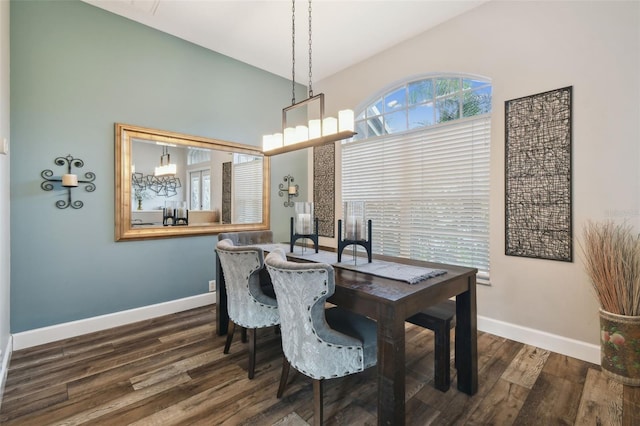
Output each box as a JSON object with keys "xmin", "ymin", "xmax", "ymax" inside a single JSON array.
[{"xmin": 313, "ymin": 144, "xmax": 336, "ymax": 238}]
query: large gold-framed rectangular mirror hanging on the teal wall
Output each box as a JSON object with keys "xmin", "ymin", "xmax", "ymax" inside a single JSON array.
[{"xmin": 115, "ymin": 123, "xmax": 270, "ymax": 241}]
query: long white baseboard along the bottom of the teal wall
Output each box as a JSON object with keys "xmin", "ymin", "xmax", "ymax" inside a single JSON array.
[{"xmin": 13, "ymin": 292, "xmax": 216, "ymax": 351}]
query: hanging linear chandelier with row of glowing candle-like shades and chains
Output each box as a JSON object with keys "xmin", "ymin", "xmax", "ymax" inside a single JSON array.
[{"xmin": 262, "ymin": 0, "xmax": 355, "ymax": 156}]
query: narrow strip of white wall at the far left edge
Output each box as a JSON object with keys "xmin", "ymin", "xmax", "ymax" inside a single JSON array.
[{"xmin": 0, "ymin": 0, "xmax": 11, "ymax": 392}]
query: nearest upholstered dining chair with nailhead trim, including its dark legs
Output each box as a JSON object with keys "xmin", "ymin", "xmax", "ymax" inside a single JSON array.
[{"xmin": 265, "ymin": 249, "xmax": 377, "ymax": 425}]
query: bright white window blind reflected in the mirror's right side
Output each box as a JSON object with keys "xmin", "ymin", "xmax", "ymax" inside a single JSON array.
[{"xmin": 233, "ymin": 156, "xmax": 262, "ymax": 223}]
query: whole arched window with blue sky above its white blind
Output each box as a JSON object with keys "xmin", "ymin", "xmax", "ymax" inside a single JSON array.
[{"xmin": 342, "ymin": 74, "xmax": 491, "ymax": 279}]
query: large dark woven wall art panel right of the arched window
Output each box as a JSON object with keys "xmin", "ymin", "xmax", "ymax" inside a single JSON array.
[{"xmin": 505, "ymin": 86, "xmax": 573, "ymax": 262}]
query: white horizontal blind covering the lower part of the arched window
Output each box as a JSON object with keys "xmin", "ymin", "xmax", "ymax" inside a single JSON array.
[{"xmin": 342, "ymin": 115, "xmax": 491, "ymax": 279}]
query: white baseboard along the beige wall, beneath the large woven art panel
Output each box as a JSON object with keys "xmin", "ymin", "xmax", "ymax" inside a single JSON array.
[{"xmin": 478, "ymin": 315, "xmax": 600, "ymax": 365}]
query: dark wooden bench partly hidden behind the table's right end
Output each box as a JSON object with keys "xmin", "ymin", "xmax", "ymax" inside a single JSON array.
[{"xmin": 407, "ymin": 300, "xmax": 456, "ymax": 392}]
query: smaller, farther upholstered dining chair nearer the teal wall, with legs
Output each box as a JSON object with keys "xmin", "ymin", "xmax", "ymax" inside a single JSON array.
[{"xmin": 216, "ymin": 239, "xmax": 280, "ymax": 379}]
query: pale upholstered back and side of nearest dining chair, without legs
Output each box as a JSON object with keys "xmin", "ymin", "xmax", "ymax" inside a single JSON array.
[{"xmin": 265, "ymin": 249, "xmax": 365, "ymax": 379}]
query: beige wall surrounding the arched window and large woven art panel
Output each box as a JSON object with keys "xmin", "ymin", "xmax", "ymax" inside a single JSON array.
[{"xmin": 316, "ymin": 1, "xmax": 640, "ymax": 362}]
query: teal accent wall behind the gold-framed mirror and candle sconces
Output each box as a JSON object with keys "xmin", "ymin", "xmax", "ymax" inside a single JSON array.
[{"xmin": 10, "ymin": 0, "xmax": 306, "ymax": 333}]
